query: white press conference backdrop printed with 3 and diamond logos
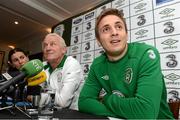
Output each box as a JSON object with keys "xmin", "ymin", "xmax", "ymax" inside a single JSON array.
[{"xmin": 53, "ymin": 0, "xmax": 180, "ymax": 101}]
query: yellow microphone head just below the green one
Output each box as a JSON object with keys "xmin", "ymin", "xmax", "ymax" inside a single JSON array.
[{"xmin": 27, "ymin": 71, "xmax": 47, "ymax": 86}]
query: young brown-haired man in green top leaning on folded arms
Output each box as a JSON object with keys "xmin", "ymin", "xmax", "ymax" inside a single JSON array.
[{"xmin": 78, "ymin": 8, "xmax": 173, "ymax": 119}]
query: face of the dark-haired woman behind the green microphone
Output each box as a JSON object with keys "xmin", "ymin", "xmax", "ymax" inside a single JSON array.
[{"xmin": 11, "ymin": 52, "xmax": 29, "ymax": 70}]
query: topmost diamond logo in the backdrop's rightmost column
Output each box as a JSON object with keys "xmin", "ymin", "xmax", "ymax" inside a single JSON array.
[{"xmin": 159, "ymin": 8, "xmax": 175, "ymax": 19}]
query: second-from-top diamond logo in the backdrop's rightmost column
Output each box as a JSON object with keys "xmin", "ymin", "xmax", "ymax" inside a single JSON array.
[{"xmin": 161, "ymin": 38, "xmax": 178, "ymax": 50}]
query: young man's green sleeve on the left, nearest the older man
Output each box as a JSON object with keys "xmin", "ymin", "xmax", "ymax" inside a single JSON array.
[{"xmin": 78, "ymin": 65, "xmax": 115, "ymax": 117}]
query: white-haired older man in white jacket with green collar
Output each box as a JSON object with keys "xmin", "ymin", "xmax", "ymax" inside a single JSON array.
[{"xmin": 40, "ymin": 33, "xmax": 83, "ymax": 110}]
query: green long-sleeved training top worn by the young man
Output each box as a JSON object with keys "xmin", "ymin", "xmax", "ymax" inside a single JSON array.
[{"xmin": 79, "ymin": 43, "xmax": 173, "ymax": 119}]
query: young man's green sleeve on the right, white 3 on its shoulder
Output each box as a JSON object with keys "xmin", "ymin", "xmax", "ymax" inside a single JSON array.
[{"xmin": 103, "ymin": 49, "xmax": 163, "ymax": 119}]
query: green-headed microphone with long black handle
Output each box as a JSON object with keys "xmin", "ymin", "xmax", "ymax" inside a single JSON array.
[{"xmin": 0, "ymin": 59, "xmax": 43, "ymax": 93}]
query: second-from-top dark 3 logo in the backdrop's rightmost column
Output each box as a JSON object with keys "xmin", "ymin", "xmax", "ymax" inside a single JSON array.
[{"xmin": 166, "ymin": 54, "xmax": 178, "ymax": 68}]
